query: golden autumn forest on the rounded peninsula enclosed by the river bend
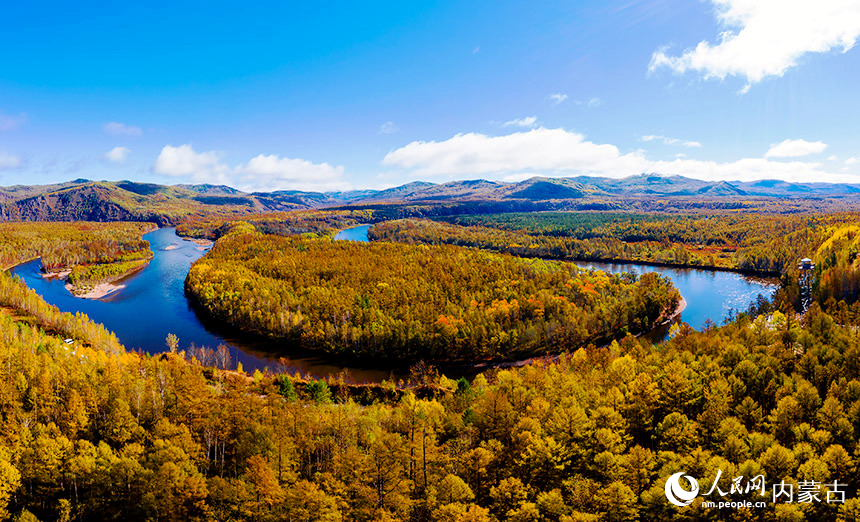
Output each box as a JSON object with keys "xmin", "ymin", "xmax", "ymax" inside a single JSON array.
[{"xmin": 186, "ymin": 222, "xmax": 679, "ymax": 361}]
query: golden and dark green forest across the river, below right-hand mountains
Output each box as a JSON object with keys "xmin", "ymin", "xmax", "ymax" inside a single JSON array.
[{"xmin": 371, "ymin": 212, "xmax": 857, "ymax": 274}]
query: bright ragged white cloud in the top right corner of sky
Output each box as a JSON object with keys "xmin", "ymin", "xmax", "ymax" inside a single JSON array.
[{"xmin": 649, "ymin": 0, "xmax": 860, "ymax": 88}]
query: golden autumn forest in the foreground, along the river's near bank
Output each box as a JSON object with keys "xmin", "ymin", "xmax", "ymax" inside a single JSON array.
[{"xmin": 5, "ymin": 250, "xmax": 860, "ymax": 521}]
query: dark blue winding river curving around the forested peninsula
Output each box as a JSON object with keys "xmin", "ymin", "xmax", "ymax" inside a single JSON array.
[{"xmin": 10, "ymin": 225, "xmax": 777, "ymax": 382}]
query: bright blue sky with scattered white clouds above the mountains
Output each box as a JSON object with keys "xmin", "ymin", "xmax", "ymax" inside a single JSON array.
[{"xmin": 0, "ymin": 0, "xmax": 860, "ymax": 190}]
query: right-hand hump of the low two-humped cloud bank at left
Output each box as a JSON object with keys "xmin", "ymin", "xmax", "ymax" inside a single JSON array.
[{"xmin": 236, "ymin": 154, "xmax": 349, "ymax": 191}]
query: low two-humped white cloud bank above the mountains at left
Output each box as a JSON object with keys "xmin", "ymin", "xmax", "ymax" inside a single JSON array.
[{"xmin": 152, "ymin": 145, "xmax": 349, "ymax": 191}]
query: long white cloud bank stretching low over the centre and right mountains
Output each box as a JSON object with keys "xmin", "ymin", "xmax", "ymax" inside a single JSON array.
[{"xmin": 382, "ymin": 127, "xmax": 860, "ymax": 182}]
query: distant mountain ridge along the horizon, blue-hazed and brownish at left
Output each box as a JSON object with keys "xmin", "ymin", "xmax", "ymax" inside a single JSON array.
[{"xmin": 0, "ymin": 174, "xmax": 860, "ymax": 220}]
